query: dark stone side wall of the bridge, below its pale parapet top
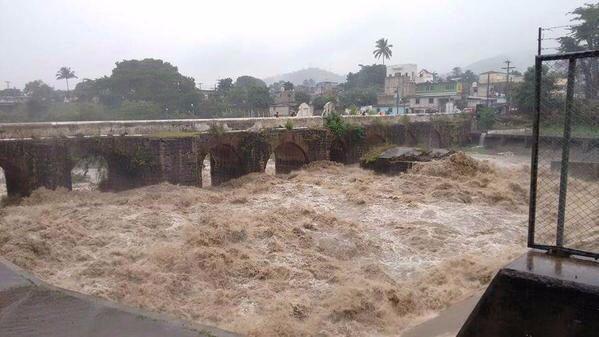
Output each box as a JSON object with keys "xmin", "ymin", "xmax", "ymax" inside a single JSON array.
[{"xmin": 0, "ymin": 120, "xmax": 470, "ymax": 196}]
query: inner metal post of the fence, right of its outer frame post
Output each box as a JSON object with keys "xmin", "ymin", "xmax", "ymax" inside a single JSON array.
[{"xmin": 555, "ymin": 57, "xmax": 576, "ymax": 248}]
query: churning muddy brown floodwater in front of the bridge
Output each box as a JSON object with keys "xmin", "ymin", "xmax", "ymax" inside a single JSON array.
[{"xmin": 0, "ymin": 153, "xmax": 528, "ymax": 336}]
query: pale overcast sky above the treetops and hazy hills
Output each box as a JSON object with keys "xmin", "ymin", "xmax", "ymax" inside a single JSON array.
[{"xmin": 0, "ymin": 0, "xmax": 590, "ymax": 89}]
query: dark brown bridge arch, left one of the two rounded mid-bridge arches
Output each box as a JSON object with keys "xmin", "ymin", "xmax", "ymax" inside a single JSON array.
[{"xmin": 207, "ymin": 143, "xmax": 244, "ymax": 186}]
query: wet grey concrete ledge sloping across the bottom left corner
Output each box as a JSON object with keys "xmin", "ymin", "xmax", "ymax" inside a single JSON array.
[{"xmin": 0, "ymin": 258, "xmax": 241, "ymax": 337}]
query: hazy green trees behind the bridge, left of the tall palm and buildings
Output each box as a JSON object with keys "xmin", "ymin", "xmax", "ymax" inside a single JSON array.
[{"xmin": 0, "ymin": 59, "xmax": 398, "ymax": 122}]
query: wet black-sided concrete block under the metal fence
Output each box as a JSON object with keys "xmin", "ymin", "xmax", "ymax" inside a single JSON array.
[{"xmin": 458, "ymin": 251, "xmax": 599, "ymax": 337}]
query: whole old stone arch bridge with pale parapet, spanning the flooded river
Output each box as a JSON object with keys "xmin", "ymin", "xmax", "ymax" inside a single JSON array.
[{"xmin": 0, "ymin": 117, "xmax": 470, "ymax": 196}]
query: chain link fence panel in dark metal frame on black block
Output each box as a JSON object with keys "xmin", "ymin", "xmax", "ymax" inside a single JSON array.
[{"xmin": 528, "ymin": 51, "xmax": 599, "ymax": 259}]
